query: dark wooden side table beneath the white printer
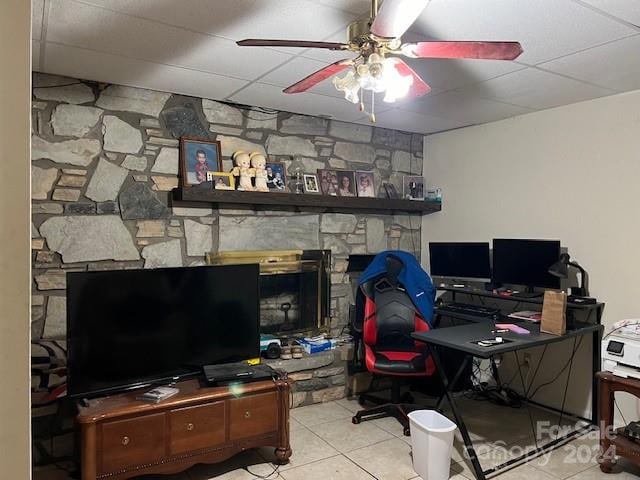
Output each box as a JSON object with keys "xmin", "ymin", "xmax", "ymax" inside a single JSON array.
[{"xmin": 596, "ymin": 372, "xmax": 640, "ymax": 473}]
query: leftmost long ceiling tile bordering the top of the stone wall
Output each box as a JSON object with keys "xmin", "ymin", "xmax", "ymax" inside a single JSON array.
[{"xmin": 41, "ymin": 43, "xmax": 247, "ymax": 100}]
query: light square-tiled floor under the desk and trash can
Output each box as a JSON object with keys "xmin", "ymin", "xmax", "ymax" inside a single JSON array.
[{"xmin": 34, "ymin": 398, "xmax": 640, "ymax": 480}]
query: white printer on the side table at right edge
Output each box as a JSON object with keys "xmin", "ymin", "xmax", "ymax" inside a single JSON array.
[{"xmin": 602, "ymin": 319, "xmax": 640, "ymax": 379}]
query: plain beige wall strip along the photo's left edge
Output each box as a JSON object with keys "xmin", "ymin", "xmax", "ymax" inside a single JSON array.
[{"xmin": 0, "ymin": 0, "xmax": 31, "ymax": 479}]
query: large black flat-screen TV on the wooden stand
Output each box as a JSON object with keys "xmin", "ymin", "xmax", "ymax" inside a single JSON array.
[{"xmin": 67, "ymin": 264, "xmax": 260, "ymax": 396}]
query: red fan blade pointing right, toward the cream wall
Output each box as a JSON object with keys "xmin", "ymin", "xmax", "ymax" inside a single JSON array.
[{"xmin": 402, "ymin": 42, "xmax": 522, "ymax": 60}]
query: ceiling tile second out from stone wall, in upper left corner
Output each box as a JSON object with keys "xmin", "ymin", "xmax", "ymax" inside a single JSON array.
[{"xmin": 47, "ymin": 0, "xmax": 290, "ymax": 79}]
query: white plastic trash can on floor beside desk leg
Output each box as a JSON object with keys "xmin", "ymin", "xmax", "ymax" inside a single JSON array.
[{"xmin": 409, "ymin": 410, "xmax": 458, "ymax": 480}]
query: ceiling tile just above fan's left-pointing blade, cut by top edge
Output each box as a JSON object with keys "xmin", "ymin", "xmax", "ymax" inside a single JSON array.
[{"xmin": 79, "ymin": 0, "xmax": 356, "ymax": 40}]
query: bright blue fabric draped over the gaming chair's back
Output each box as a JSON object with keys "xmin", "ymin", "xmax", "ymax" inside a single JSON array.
[{"xmin": 358, "ymin": 250, "xmax": 436, "ymax": 327}]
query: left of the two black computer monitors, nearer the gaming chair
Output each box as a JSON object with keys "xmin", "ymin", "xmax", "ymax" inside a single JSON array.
[{"xmin": 429, "ymin": 242, "xmax": 491, "ymax": 280}]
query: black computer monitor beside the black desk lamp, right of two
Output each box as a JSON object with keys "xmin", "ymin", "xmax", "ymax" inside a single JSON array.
[{"xmin": 493, "ymin": 238, "xmax": 560, "ymax": 291}]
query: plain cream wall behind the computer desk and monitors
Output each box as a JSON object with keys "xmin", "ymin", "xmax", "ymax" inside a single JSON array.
[{"xmin": 422, "ymin": 91, "xmax": 640, "ymax": 418}]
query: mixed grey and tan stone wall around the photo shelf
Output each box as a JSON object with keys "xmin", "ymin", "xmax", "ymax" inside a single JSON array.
[{"xmin": 32, "ymin": 74, "xmax": 422, "ymax": 339}]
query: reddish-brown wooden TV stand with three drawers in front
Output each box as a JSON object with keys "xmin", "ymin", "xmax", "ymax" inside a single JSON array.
[{"xmin": 76, "ymin": 380, "xmax": 291, "ymax": 480}]
